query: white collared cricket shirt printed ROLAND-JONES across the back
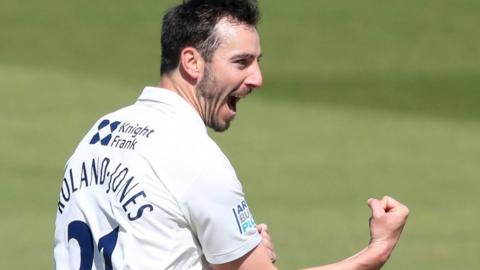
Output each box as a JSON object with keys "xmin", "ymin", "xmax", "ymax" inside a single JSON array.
[{"xmin": 54, "ymin": 87, "xmax": 261, "ymax": 270}]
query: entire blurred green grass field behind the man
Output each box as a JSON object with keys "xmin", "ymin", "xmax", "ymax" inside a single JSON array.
[{"xmin": 0, "ymin": 0, "xmax": 480, "ymax": 270}]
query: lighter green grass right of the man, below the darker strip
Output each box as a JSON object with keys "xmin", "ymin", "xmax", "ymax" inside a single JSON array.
[{"xmin": 215, "ymin": 101, "xmax": 480, "ymax": 269}]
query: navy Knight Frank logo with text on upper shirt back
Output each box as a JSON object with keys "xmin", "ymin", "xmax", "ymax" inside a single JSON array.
[{"xmin": 90, "ymin": 119, "xmax": 155, "ymax": 150}]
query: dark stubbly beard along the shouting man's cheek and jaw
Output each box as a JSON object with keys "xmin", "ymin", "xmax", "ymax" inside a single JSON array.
[{"xmin": 196, "ymin": 64, "xmax": 230, "ymax": 132}]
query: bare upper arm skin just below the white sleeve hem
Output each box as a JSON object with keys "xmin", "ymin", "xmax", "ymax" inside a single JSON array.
[{"xmin": 211, "ymin": 245, "xmax": 277, "ymax": 270}]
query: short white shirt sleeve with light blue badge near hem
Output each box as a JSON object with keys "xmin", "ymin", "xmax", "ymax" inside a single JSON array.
[{"xmin": 183, "ymin": 148, "xmax": 261, "ymax": 264}]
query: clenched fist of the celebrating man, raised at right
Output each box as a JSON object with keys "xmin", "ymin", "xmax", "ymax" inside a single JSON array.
[{"xmin": 368, "ymin": 196, "xmax": 410, "ymax": 254}]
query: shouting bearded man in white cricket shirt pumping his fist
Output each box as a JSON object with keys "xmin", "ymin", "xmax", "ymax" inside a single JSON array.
[{"xmin": 54, "ymin": 0, "xmax": 408, "ymax": 270}]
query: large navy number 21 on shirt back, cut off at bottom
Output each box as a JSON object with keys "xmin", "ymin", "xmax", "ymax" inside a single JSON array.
[{"xmin": 68, "ymin": 220, "xmax": 119, "ymax": 270}]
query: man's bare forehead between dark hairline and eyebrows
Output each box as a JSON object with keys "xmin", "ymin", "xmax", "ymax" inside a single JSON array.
[{"xmin": 215, "ymin": 18, "xmax": 261, "ymax": 57}]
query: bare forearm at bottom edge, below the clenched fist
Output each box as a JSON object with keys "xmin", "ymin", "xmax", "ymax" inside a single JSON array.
[{"xmin": 304, "ymin": 245, "xmax": 393, "ymax": 270}]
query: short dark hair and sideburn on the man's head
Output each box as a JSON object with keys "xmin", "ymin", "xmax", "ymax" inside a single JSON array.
[{"xmin": 160, "ymin": 0, "xmax": 260, "ymax": 75}]
